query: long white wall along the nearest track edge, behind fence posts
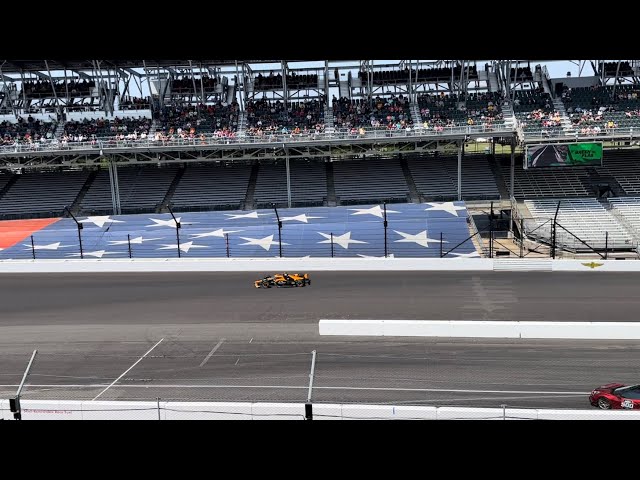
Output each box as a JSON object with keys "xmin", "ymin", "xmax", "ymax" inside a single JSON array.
[{"xmin": 0, "ymin": 399, "xmax": 640, "ymax": 420}]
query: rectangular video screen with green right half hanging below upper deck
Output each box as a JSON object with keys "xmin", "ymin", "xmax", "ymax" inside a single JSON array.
[{"xmin": 525, "ymin": 142, "xmax": 602, "ymax": 168}]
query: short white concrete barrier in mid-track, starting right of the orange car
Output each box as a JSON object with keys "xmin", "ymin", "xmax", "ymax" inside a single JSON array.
[{"xmin": 318, "ymin": 319, "xmax": 640, "ymax": 340}]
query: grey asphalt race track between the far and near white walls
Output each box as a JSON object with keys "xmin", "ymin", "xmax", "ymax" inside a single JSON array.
[{"xmin": 0, "ymin": 272, "xmax": 640, "ymax": 408}]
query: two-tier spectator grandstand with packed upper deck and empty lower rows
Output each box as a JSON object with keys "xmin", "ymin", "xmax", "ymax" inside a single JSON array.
[{"xmin": 0, "ymin": 60, "xmax": 640, "ymax": 258}]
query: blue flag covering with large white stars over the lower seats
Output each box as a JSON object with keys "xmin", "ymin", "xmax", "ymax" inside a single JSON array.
[{"xmin": 0, "ymin": 202, "xmax": 480, "ymax": 259}]
